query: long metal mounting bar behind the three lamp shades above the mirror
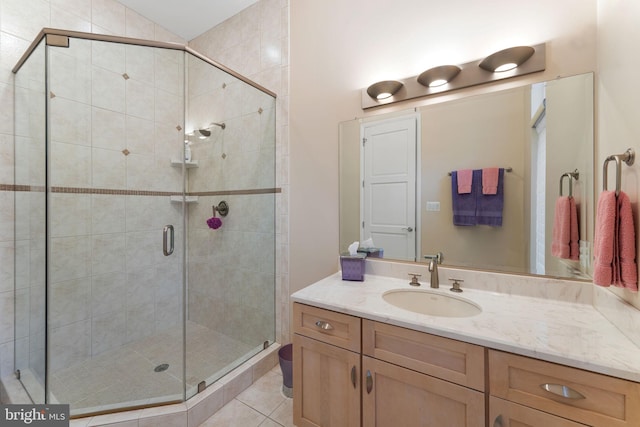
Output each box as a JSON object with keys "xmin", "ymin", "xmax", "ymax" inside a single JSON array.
[{"xmin": 361, "ymin": 43, "xmax": 546, "ymax": 110}]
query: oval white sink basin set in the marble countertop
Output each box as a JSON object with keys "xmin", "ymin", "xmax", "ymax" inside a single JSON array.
[{"xmin": 382, "ymin": 289, "xmax": 482, "ymax": 317}]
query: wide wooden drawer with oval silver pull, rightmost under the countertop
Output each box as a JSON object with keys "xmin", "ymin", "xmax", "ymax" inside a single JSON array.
[{"xmin": 489, "ymin": 350, "xmax": 640, "ymax": 427}]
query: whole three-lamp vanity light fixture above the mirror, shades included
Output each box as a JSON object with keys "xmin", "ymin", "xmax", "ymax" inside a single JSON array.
[{"xmin": 361, "ymin": 43, "xmax": 546, "ymax": 110}]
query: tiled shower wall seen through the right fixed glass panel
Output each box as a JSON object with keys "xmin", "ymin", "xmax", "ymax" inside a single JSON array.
[{"xmin": 187, "ymin": 57, "xmax": 277, "ymax": 348}]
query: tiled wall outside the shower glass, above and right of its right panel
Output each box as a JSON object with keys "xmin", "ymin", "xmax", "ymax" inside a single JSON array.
[{"xmin": 189, "ymin": 0, "xmax": 291, "ymax": 343}]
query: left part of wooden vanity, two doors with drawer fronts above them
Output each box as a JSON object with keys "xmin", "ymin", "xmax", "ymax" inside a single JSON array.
[{"xmin": 293, "ymin": 303, "xmax": 485, "ymax": 427}]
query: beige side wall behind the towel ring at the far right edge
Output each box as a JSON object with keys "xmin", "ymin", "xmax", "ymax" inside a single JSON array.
[{"xmin": 595, "ymin": 0, "xmax": 640, "ymax": 308}]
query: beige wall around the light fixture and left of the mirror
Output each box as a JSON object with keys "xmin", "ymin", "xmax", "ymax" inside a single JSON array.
[{"xmin": 289, "ymin": 0, "xmax": 596, "ymax": 292}]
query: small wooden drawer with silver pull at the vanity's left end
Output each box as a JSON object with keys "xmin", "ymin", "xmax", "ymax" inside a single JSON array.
[{"xmin": 293, "ymin": 303, "xmax": 361, "ymax": 353}]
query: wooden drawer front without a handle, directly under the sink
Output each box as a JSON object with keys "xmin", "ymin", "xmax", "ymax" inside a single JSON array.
[{"xmin": 362, "ymin": 319, "xmax": 485, "ymax": 391}]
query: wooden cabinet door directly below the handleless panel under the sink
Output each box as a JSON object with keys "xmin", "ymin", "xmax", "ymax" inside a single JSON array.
[{"xmin": 362, "ymin": 356, "xmax": 485, "ymax": 427}]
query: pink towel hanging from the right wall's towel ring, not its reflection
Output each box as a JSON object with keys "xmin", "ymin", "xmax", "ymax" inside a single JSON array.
[{"xmin": 593, "ymin": 191, "xmax": 638, "ymax": 292}]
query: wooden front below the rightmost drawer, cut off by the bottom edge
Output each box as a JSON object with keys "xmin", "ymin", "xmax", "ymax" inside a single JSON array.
[{"xmin": 489, "ymin": 396, "xmax": 585, "ymax": 427}]
